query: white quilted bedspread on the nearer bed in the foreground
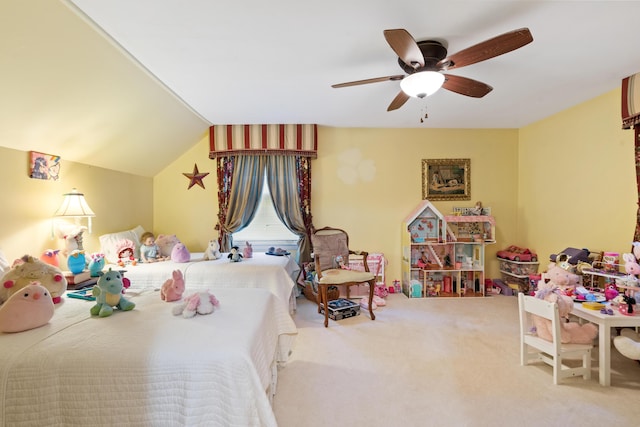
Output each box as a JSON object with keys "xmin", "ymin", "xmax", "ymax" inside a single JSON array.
[{"xmin": 0, "ymin": 288, "xmax": 297, "ymax": 427}]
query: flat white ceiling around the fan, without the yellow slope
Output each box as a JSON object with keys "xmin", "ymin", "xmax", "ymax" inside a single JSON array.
[{"xmin": 71, "ymin": 0, "xmax": 640, "ymax": 128}]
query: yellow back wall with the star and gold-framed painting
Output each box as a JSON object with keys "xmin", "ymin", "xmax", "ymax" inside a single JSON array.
[{"xmin": 154, "ymin": 127, "xmax": 518, "ymax": 283}]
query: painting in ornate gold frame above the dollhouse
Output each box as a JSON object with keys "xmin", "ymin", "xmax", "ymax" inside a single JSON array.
[{"xmin": 422, "ymin": 159, "xmax": 471, "ymax": 200}]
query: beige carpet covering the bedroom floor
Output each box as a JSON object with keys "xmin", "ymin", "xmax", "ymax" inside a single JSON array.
[{"xmin": 273, "ymin": 294, "xmax": 640, "ymax": 427}]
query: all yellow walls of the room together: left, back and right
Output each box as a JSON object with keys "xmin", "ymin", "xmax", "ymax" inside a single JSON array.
[{"xmin": 5, "ymin": 90, "xmax": 637, "ymax": 283}]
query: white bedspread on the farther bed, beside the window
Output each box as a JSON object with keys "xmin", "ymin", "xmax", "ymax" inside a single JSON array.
[{"xmin": 107, "ymin": 253, "xmax": 298, "ymax": 309}]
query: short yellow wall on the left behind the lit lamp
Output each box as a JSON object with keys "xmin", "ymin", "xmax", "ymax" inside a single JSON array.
[{"xmin": 0, "ymin": 147, "xmax": 153, "ymax": 261}]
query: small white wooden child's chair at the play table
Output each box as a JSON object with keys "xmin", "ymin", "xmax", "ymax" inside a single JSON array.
[{"xmin": 518, "ymin": 293, "xmax": 593, "ymax": 384}]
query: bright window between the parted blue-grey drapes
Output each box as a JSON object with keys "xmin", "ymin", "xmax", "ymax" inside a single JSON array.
[{"xmin": 233, "ymin": 175, "xmax": 298, "ymax": 246}]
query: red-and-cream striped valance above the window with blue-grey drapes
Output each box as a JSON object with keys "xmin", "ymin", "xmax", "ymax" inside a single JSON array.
[{"xmin": 209, "ymin": 125, "xmax": 318, "ymax": 159}]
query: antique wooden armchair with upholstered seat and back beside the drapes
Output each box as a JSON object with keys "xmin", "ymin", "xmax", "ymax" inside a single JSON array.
[{"xmin": 311, "ymin": 227, "xmax": 376, "ymax": 327}]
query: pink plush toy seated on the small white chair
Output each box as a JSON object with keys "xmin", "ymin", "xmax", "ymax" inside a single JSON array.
[{"xmin": 533, "ymin": 263, "xmax": 598, "ymax": 344}]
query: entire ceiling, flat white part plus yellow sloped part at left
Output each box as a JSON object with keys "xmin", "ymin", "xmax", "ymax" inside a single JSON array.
[{"xmin": 0, "ymin": 0, "xmax": 640, "ymax": 176}]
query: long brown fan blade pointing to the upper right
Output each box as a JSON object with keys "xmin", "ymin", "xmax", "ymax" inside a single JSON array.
[{"xmin": 437, "ymin": 28, "xmax": 533, "ymax": 70}]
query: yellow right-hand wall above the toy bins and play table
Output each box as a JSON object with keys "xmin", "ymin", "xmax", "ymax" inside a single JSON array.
[{"xmin": 520, "ymin": 90, "xmax": 638, "ymax": 267}]
